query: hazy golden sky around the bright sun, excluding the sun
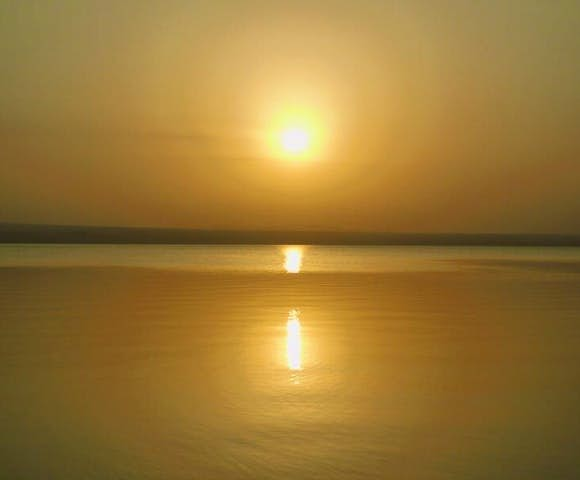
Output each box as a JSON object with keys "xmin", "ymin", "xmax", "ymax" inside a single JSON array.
[{"xmin": 0, "ymin": 0, "xmax": 580, "ymax": 233}]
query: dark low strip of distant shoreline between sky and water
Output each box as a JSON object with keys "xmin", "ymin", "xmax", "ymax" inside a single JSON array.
[{"xmin": 0, "ymin": 223, "xmax": 580, "ymax": 247}]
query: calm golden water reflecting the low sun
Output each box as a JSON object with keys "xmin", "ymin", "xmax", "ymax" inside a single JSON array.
[{"xmin": 0, "ymin": 245, "xmax": 580, "ymax": 479}]
